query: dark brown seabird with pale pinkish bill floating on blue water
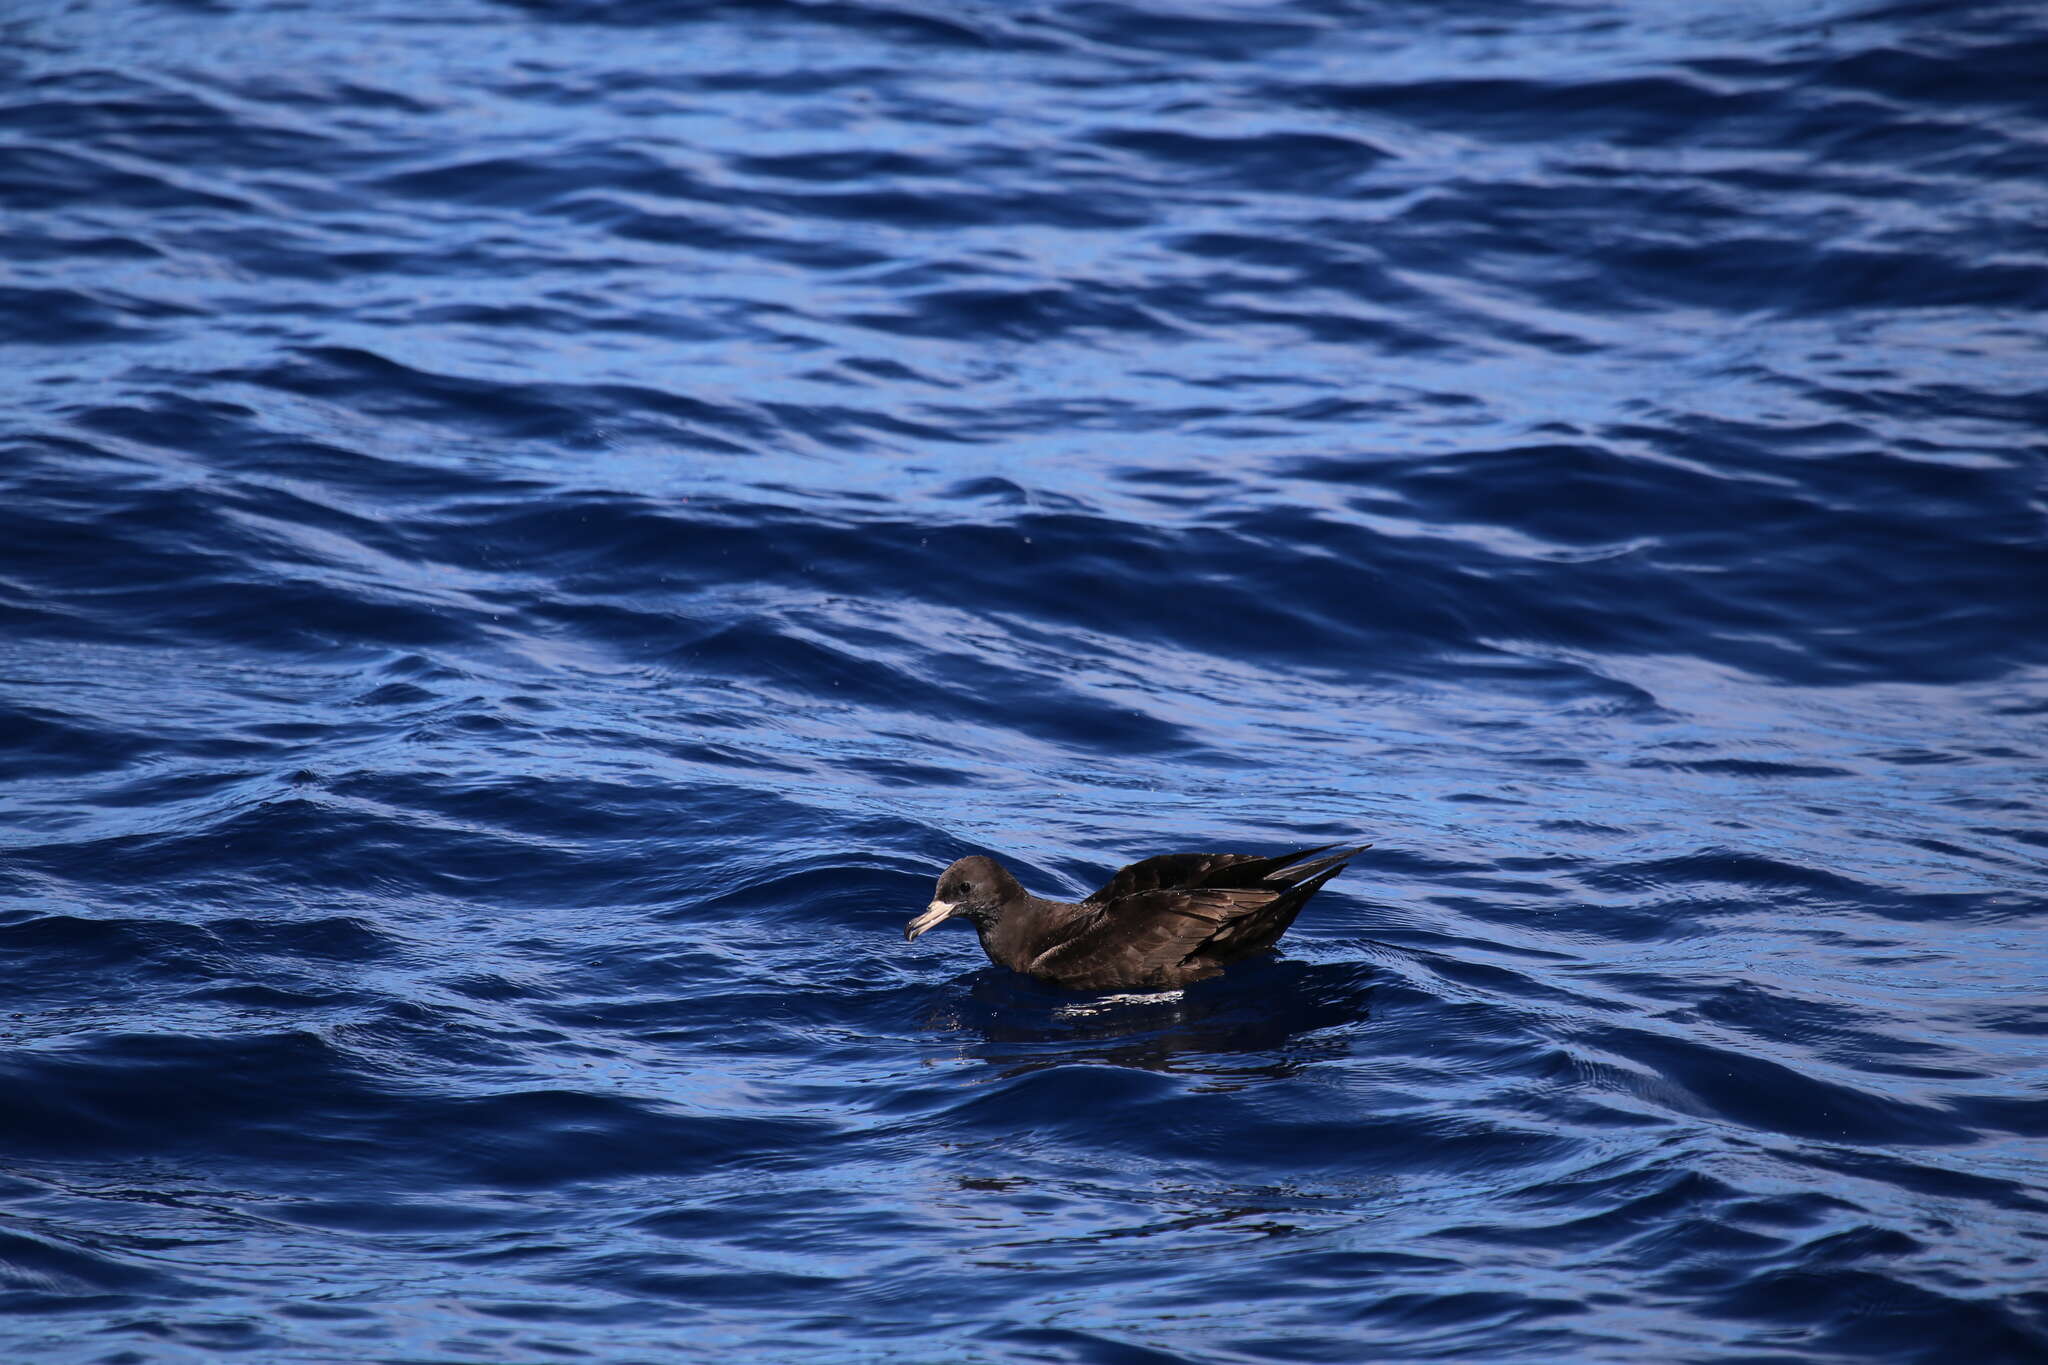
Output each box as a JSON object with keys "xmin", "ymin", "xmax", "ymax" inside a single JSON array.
[{"xmin": 903, "ymin": 843, "xmax": 1372, "ymax": 990}]
